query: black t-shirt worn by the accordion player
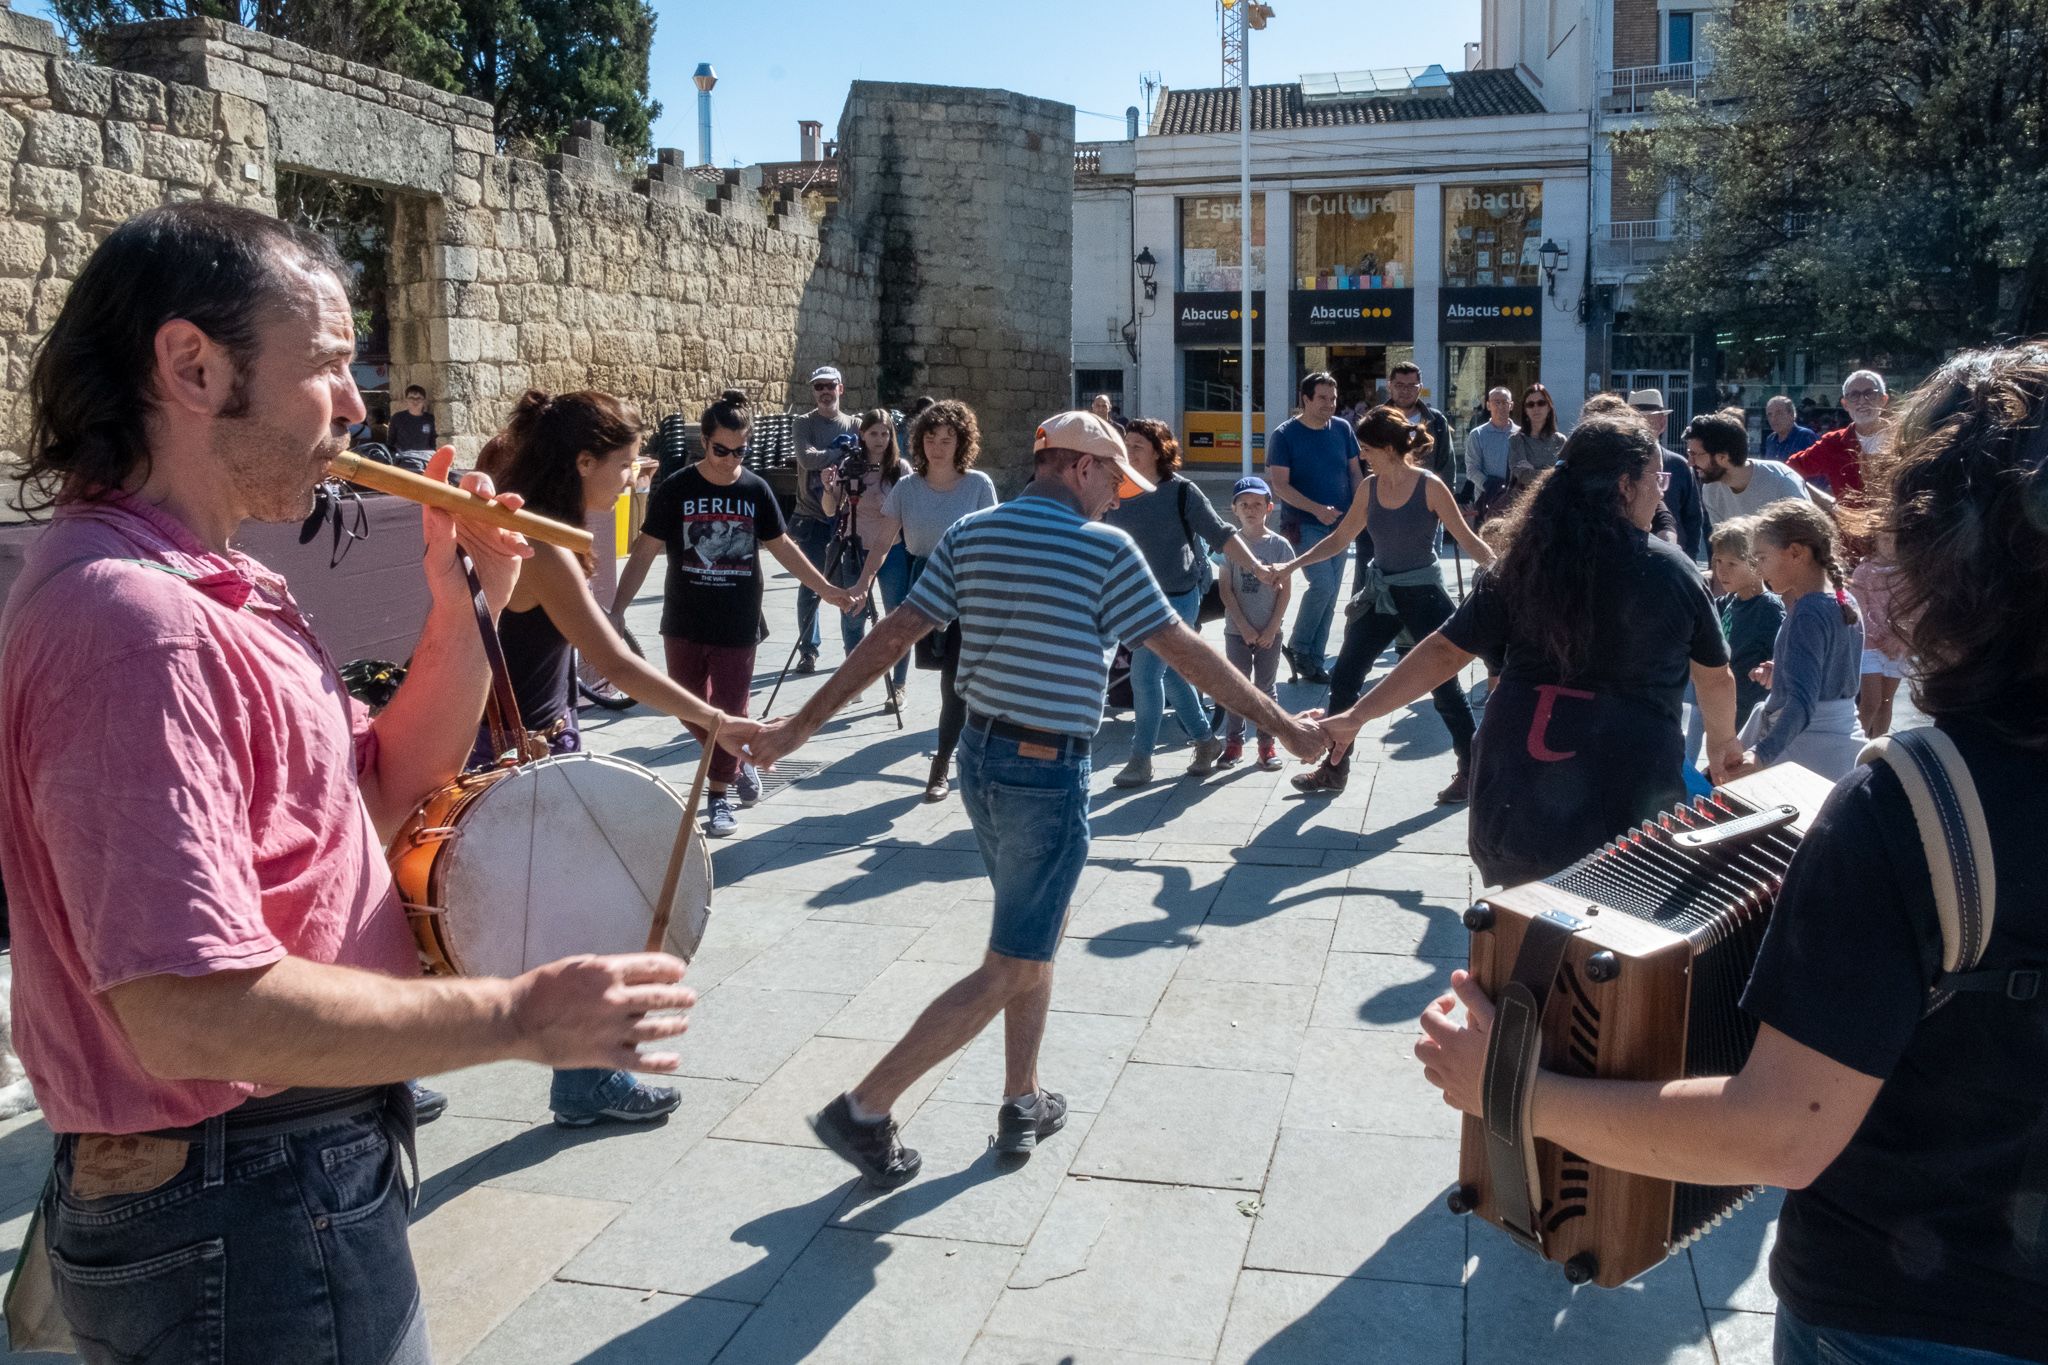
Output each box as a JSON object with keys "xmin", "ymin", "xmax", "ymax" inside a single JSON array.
[{"xmin": 1743, "ymin": 722, "xmax": 2048, "ymax": 1361}]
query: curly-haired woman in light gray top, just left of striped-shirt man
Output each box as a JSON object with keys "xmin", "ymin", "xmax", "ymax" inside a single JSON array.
[{"xmin": 854, "ymin": 399, "xmax": 995, "ymax": 800}]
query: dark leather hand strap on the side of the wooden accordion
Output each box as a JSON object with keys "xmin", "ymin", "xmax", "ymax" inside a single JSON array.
[{"xmin": 1481, "ymin": 911, "xmax": 1585, "ymax": 1252}]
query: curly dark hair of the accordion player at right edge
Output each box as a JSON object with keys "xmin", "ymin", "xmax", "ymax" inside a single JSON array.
[{"xmin": 1872, "ymin": 342, "xmax": 2048, "ymax": 751}]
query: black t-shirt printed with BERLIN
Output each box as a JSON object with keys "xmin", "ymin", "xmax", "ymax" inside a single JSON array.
[{"xmin": 641, "ymin": 465, "xmax": 784, "ymax": 645}]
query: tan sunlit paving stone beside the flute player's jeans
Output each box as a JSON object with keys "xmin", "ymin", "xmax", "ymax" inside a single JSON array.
[{"xmin": 412, "ymin": 1185, "xmax": 625, "ymax": 1361}]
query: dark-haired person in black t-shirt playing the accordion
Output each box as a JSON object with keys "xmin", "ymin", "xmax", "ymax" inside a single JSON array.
[{"xmin": 1415, "ymin": 346, "xmax": 2048, "ymax": 1365}]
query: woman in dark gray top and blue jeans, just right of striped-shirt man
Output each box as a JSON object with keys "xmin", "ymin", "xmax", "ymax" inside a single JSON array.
[{"xmin": 1102, "ymin": 417, "xmax": 1262, "ymax": 786}]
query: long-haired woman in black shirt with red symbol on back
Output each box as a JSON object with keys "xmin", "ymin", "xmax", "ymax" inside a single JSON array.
[{"xmin": 1325, "ymin": 413, "xmax": 1741, "ymax": 886}]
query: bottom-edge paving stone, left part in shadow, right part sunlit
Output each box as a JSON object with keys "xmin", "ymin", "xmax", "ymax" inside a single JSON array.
[{"xmin": 727, "ymin": 1228, "xmax": 1018, "ymax": 1365}]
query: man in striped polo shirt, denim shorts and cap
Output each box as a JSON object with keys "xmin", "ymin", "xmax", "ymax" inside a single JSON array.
[{"xmin": 754, "ymin": 411, "xmax": 1327, "ymax": 1189}]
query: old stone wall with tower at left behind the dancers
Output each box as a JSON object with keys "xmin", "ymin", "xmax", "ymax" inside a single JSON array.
[{"xmin": 0, "ymin": 12, "xmax": 1073, "ymax": 501}]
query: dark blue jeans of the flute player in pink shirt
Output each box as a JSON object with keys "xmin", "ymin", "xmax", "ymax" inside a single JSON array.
[{"xmin": 43, "ymin": 1115, "xmax": 428, "ymax": 1365}]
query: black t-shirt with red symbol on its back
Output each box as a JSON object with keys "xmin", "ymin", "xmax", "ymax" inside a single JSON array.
[{"xmin": 1442, "ymin": 530, "xmax": 1729, "ymax": 886}]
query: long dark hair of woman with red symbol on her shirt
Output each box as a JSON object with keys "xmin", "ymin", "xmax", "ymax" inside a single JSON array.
[{"xmin": 1487, "ymin": 413, "xmax": 1657, "ymax": 679}]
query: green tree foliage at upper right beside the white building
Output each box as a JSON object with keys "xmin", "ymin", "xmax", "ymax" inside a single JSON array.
[{"xmin": 1630, "ymin": 0, "xmax": 2048, "ymax": 354}]
